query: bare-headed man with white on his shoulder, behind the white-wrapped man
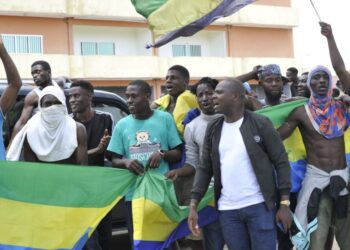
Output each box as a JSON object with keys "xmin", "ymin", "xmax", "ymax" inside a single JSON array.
[{"xmin": 11, "ymin": 61, "xmax": 58, "ymax": 139}]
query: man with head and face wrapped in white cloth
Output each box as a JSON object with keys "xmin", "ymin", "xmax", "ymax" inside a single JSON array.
[{"xmin": 7, "ymin": 86, "xmax": 87, "ymax": 165}]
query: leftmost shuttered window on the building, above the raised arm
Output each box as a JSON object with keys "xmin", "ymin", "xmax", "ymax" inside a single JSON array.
[{"xmin": 2, "ymin": 34, "xmax": 43, "ymax": 54}]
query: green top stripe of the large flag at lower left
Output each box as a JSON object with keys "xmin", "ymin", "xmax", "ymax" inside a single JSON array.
[{"xmin": 0, "ymin": 161, "xmax": 136, "ymax": 208}]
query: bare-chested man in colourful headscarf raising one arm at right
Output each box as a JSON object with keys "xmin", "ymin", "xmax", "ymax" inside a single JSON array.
[{"xmin": 279, "ymin": 23, "xmax": 350, "ymax": 249}]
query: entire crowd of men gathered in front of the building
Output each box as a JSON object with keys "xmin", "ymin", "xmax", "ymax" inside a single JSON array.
[{"xmin": 0, "ymin": 22, "xmax": 350, "ymax": 250}]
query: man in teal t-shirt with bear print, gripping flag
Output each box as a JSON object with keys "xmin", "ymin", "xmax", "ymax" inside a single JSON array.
[{"xmin": 107, "ymin": 80, "xmax": 182, "ymax": 246}]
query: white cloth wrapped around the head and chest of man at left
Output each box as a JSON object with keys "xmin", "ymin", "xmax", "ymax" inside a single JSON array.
[{"xmin": 7, "ymin": 86, "xmax": 78, "ymax": 162}]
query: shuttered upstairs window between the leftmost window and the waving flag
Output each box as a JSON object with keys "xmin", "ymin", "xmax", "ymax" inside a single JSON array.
[{"xmin": 81, "ymin": 42, "xmax": 115, "ymax": 56}]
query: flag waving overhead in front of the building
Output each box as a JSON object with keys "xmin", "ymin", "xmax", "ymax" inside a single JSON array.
[{"xmin": 131, "ymin": 0, "xmax": 256, "ymax": 47}]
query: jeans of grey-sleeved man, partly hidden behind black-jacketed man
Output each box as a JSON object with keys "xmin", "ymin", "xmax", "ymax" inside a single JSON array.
[{"xmin": 203, "ymin": 220, "xmax": 225, "ymax": 250}]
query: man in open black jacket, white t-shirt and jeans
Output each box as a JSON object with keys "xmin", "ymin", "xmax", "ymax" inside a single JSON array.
[{"xmin": 188, "ymin": 78, "xmax": 291, "ymax": 250}]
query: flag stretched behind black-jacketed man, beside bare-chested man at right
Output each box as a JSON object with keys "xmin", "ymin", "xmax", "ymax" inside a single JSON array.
[{"xmin": 256, "ymin": 99, "xmax": 307, "ymax": 192}]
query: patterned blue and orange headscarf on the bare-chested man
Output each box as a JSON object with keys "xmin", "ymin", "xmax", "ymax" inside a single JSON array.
[{"xmin": 305, "ymin": 65, "xmax": 349, "ymax": 139}]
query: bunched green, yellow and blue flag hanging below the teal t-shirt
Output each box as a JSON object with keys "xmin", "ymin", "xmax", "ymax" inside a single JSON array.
[{"xmin": 132, "ymin": 172, "xmax": 218, "ymax": 250}]
